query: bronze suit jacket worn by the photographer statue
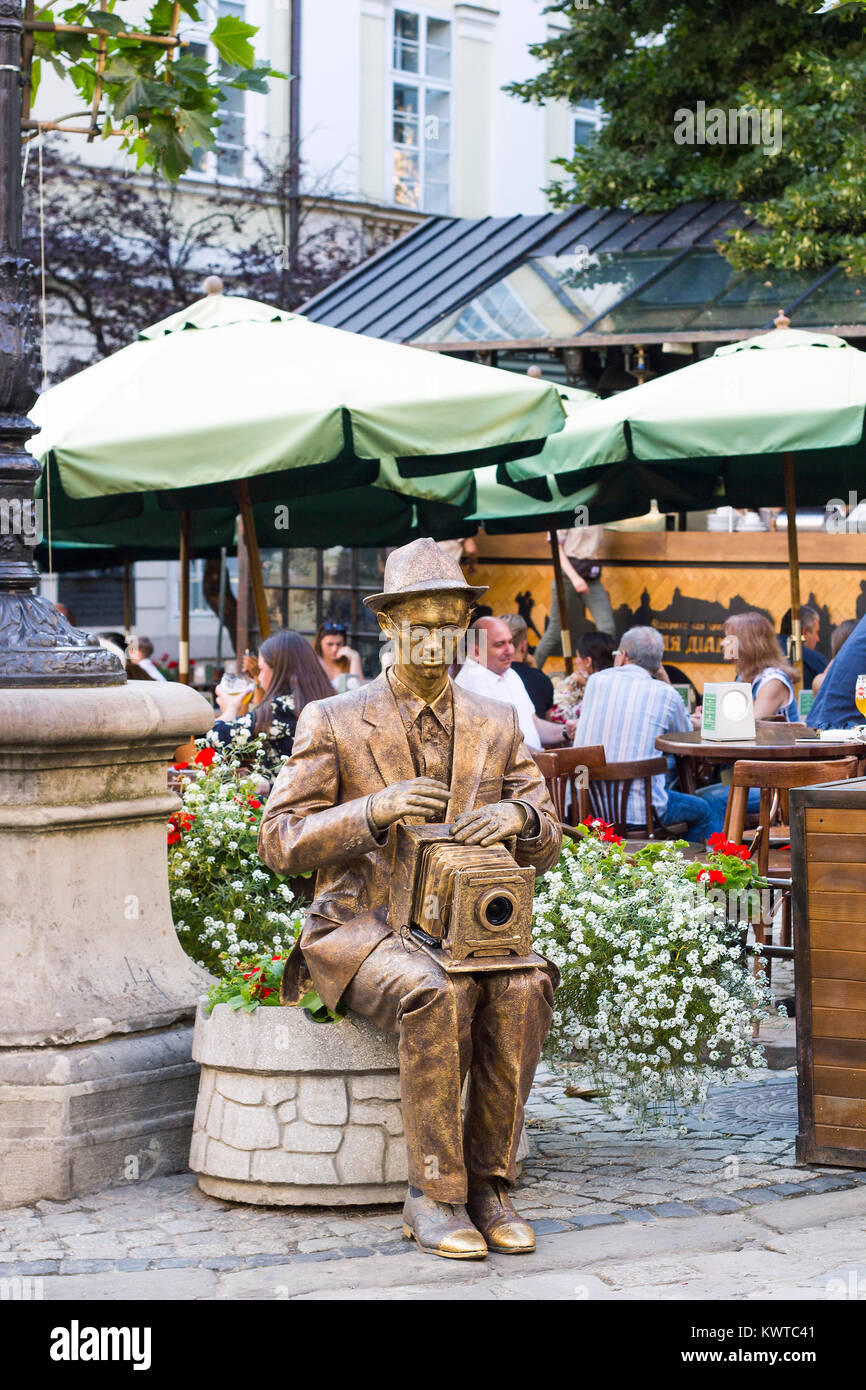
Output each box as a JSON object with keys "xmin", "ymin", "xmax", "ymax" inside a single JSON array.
[{"xmin": 259, "ymin": 676, "xmax": 562, "ymax": 1008}]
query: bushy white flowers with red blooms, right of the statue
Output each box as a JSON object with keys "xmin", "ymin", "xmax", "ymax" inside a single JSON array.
[{"xmin": 534, "ymin": 821, "xmax": 770, "ymax": 1122}]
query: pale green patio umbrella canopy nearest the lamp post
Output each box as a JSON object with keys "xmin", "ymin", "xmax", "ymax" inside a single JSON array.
[{"xmin": 31, "ymin": 296, "xmax": 564, "ymax": 509}]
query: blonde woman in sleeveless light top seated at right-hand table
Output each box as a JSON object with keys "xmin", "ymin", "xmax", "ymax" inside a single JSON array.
[{"xmin": 698, "ymin": 612, "xmax": 799, "ymax": 815}]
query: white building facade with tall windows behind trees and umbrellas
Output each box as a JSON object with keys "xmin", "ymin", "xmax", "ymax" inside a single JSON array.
[{"xmin": 29, "ymin": 0, "xmax": 589, "ymax": 664}]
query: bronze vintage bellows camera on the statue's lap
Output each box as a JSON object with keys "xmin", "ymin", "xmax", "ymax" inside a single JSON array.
[{"xmin": 388, "ymin": 824, "xmax": 539, "ymax": 972}]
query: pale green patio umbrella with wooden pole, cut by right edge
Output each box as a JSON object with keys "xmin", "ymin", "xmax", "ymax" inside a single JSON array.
[{"xmin": 499, "ymin": 316, "xmax": 866, "ymax": 678}]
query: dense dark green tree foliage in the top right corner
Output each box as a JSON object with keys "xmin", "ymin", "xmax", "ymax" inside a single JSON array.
[{"xmin": 509, "ymin": 0, "xmax": 866, "ymax": 274}]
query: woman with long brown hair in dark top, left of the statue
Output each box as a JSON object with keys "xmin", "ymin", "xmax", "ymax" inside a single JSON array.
[{"xmin": 206, "ymin": 631, "xmax": 334, "ymax": 781}]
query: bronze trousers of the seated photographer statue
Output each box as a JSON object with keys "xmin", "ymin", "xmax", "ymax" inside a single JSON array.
[{"xmin": 343, "ymin": 935, "xmax": 553, "ymax": 1204}]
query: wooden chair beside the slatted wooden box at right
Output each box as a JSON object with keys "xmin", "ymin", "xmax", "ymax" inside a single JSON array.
[{"xmin": 724, "ymin": 758, "xmax": 859, "ymax": 1000}]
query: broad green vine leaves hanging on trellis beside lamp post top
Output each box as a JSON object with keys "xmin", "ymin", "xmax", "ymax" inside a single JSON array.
[{"xmin": 29, "ymin": 0, "xmax": 285, "ymax": 181}]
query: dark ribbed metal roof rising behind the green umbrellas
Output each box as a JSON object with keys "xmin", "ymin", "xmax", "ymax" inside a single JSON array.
[{"xmin": 300, "ymin": 202, "xmax": 755, "ymax": 342}]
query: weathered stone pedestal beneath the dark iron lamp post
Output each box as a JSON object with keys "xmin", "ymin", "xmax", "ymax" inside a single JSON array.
[{"xmin": 0, "ymin": 681, "xmax": 213, "ymax": 1205}]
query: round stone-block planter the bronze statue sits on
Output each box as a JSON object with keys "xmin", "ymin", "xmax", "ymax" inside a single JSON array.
[{"xmin": 189, "ymin": 1004, "xmax": 528, "ymax": 1207}]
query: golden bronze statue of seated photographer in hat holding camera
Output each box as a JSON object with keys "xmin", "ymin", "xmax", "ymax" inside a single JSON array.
[{"xmin": 259, "ymin": 539, "xmax": 562, "ymax": 1259}]
